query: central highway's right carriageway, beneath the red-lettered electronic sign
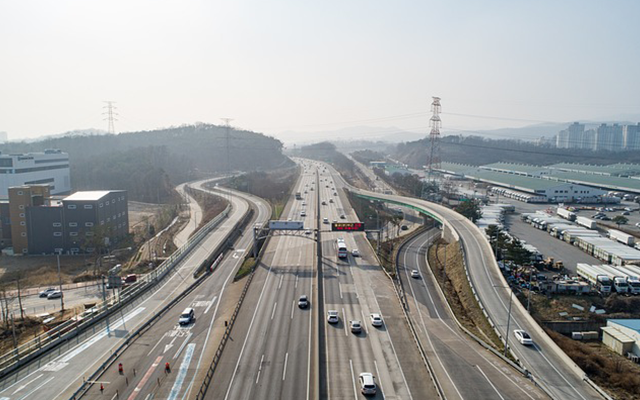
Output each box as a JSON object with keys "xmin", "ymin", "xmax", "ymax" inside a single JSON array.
[{"xmin": 320, "ymin": 168, "xmax": 437, "ymax": 399}]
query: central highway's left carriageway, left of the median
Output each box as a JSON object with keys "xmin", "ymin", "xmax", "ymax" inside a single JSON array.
[{"xmin": 207, "ymin": 163, "xmax": 317, "ymax": 399}]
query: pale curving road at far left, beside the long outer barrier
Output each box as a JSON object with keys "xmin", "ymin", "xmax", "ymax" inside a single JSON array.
[{"xmin": 0, "ymin": 182, "xmax": 269, "ymax": 400}]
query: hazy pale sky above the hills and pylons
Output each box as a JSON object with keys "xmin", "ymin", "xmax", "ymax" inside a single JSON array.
[{"xmin": 0, "ymin": 0, "xmax": 640, "ymax": 141}]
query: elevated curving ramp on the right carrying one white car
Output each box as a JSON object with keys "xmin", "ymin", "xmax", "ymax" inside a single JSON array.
[{"xmin": 342, "ymin": 181, "xmax": 601, "ymax": 399}]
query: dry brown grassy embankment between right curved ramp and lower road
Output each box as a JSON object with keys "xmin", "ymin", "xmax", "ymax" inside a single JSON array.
[{"xmin": 428, "ymin": 239, "xmax": 504, "ymax": 351}]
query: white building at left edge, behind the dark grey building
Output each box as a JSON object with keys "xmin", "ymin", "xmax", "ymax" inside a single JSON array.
[{"xmin": 0, "ymin": 150, "xmax": 71, "ymax": 198}]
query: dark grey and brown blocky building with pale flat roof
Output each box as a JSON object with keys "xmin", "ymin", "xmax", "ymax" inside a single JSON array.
[{"xmin": 0, "ymin": 185, "xmax": 129, "ymax": 254}]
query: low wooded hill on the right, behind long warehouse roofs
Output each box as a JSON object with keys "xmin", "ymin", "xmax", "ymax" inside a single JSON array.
[{"xmin": 393, "ymin": 136, "xmax": 640, "ymax": 167}]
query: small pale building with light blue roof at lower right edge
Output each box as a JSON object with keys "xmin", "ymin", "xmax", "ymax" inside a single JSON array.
[{"xmin": 600, "ymin": 319, "xmax": 640, "ymax": 362}]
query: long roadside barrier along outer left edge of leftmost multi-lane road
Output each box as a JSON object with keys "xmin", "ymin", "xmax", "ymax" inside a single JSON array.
[{"xmin": 0, "ymin": 205, "xmax": 231, "ymax": 378}]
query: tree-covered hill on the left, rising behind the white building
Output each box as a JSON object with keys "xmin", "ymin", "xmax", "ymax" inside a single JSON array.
[{"xmin": 0, "ymin": 124, "xmax": 291, "ymax": 202}]
